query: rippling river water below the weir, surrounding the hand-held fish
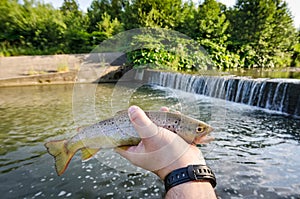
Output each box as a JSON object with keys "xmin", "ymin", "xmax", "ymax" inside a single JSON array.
[{"xmin": 0, "ymin": 84, "xmax": 300, "ymax": 199}]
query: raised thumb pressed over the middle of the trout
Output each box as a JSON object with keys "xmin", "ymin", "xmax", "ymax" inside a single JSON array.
[{"xmin": 128, "ymin": 106, "xmax": 158, "ymax": 139}]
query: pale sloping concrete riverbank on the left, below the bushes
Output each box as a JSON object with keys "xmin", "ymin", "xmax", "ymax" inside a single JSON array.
[{"xmin": 0, "ymin": 53, "xmax": 127, "ymax": 87}]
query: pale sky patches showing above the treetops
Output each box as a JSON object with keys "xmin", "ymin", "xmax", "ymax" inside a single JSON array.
[{"xmin": 44, "ymin": 0, "xmax": 300, "ymax": 29}]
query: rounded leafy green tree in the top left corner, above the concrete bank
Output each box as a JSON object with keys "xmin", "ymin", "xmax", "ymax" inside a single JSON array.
[{"xmin": 0, "ymin": 1, "xmax": 66, "ymax": 55}]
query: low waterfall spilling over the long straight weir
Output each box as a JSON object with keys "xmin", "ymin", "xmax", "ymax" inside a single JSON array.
[{"xmin": 146, "ymin": 71, "xmax": 300, "ymax": 117}]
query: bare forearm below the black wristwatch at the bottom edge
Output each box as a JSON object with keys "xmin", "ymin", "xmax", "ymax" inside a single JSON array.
[{"xmin": 166, "ymin": 181, "xmax": 217, "ymax": 199}]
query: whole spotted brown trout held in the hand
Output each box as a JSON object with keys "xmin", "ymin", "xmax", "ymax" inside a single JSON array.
[{"xmin": 45, "ymin": 111, "xmax": 212, "ymax": 175}]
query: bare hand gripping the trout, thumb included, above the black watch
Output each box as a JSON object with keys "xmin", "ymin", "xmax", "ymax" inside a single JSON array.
[{"xmin": 116, "ymin": 106, "xmax": 206, "ymax": 179}]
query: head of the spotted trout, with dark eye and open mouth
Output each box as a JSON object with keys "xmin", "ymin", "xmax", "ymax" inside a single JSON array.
[{"xmin": 176, "ymin": 117, "xmax": 213, "ymax": 144}]
